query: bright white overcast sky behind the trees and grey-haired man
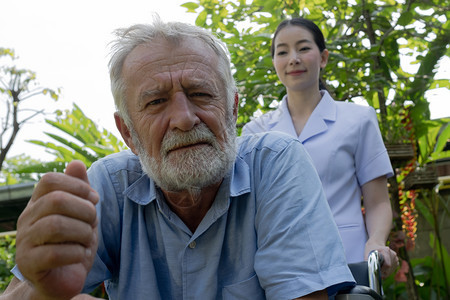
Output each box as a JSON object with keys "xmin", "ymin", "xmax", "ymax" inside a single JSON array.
[{"xmin": 0, "ymin": 0, "xmax": 450, "ymax": 160}]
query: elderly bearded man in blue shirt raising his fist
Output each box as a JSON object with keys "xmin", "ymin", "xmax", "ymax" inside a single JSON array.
[{"xmin": 1, "ymin": 19, "xmax": 354, "ymax": 299}]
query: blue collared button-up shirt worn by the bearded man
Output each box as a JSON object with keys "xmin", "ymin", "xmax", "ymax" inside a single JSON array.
[{"xmin": 12, "ymin": 133, "xmax": 353, "ymax": 299}]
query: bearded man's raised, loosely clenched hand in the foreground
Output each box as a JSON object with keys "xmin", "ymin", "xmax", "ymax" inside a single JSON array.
[{"xmin": 16, "ymin": 161, "xmax": 99, "ymax": 299}]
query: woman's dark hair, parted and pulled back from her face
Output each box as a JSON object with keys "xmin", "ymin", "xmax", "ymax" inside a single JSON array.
[{"xmin": 270, "ymin": 17, "xmax": 327, "ymax": 90}]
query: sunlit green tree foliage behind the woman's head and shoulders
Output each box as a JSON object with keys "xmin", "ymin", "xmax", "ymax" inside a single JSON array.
[{"xmin": 182, "ymin": 0, "xmax": 450, "ymax": 142}]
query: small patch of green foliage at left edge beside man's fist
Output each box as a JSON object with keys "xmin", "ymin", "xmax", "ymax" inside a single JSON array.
[{"xmin": 0, "ymin": 235, "xmax": 16, "ymax": 291}]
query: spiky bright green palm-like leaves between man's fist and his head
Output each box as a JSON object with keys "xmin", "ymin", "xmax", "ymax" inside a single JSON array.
[{"xmin": 17, "ymin": 104, "xmax": 127, "ymax": 174}]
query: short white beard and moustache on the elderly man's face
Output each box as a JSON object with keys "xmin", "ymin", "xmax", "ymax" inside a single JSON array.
[{"xmin": 131, "ymin": 119, "xmax": 237, "ymax": 193}]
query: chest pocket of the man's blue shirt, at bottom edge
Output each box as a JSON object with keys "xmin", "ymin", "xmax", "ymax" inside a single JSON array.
[{"xmin": 222, "ymin": 274, "xmax": 266, "ymax": 300}]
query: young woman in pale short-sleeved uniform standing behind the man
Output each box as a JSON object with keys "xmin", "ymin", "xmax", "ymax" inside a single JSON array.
[{"xmin": 242, "ymin": 18, "xmax": 398, "ymax": 277}]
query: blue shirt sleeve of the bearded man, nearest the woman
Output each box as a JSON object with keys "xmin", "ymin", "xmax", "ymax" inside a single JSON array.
[{"xmin": 246, "ymin": 135, "xmax": 354, "ymax": 299}]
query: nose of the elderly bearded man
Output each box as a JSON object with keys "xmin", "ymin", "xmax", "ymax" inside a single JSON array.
[{"xmin": 169, "ymin": 92, "xmax": 200, "ymax": 131}]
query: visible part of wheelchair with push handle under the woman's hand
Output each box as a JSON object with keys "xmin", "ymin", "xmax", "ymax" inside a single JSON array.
[{"xmin": 335, "ymin": 250, "xmax": 384, "ymax": 300}]
